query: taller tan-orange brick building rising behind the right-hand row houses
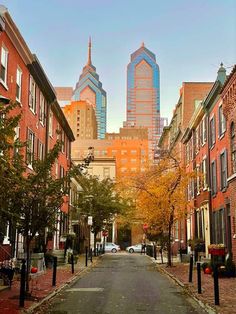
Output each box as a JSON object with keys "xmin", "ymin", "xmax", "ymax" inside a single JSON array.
[{"xmin": 159, "ymin": 82, "xmax": 212, "ymax": 254}]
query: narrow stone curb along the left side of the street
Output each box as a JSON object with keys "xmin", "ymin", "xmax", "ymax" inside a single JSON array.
[{"xmin": 21, "ymin": 255, "xmax": 102, "ymax": 313}]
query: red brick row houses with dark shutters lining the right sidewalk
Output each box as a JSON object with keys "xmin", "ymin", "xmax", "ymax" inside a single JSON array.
[{"xmin": 159, "ymin": 65, "xmax": 236, "ymax": 260}]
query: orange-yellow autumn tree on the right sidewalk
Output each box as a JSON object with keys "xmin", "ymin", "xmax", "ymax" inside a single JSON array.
[{"xmin": 132, "ymin": 154, "xmax": 192, "ymax": 266}]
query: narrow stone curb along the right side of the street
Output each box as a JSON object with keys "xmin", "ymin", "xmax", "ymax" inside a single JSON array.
[{"xmin": 150, "ymin": 257, "xmax": 217, "ymax": 314}]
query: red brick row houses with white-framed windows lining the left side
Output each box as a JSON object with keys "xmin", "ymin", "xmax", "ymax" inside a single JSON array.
[{"xmin": 0, "ymin": 5, "xmax": 74, "ymax": 258}]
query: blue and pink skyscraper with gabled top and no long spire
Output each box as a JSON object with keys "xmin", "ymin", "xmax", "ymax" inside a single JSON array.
[{"xmin": 124, "ymin": 43, "xmax": 160, "ymax": 158}]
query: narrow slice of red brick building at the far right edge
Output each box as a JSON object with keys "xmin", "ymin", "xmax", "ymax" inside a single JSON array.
[{"xmin": 221, "ymin": 66, "xmax": 236, "ymax": 262}]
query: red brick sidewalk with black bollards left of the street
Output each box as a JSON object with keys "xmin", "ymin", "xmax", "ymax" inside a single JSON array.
[{"xmin": 0, "ymin": 256, "xmax": 98, "ymax": 314}]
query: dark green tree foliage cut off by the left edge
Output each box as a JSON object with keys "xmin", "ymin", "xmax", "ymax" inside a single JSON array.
[{"xmin": 0, "ymin": 102, "xmax": 25, "ymax": 243}]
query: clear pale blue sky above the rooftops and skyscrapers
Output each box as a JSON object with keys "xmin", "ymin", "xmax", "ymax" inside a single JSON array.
[{"xmin": 0, "ymin": 0, "xmax": 236, "ymax": 132}]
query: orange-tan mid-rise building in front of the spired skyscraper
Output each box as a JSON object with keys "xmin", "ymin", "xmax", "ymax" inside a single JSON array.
[{"xmin": 63, "ymin": 100, "xmax": 97, "ymax": 140}]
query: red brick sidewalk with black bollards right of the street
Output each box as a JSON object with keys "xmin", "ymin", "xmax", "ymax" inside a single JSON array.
[{"xmin": 158, "ymin": 263, "xmax": 236, "ymax": 314}]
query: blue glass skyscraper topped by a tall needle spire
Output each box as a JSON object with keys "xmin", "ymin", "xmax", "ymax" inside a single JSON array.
[{"xmin": 73, "ymin": 39, "xmax": 107, "ymax": 139}]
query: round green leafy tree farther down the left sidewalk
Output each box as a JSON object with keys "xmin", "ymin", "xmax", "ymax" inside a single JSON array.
[{"xmin": 77, "ymin": 175, "xmax": 128, "ymax": 249}]
